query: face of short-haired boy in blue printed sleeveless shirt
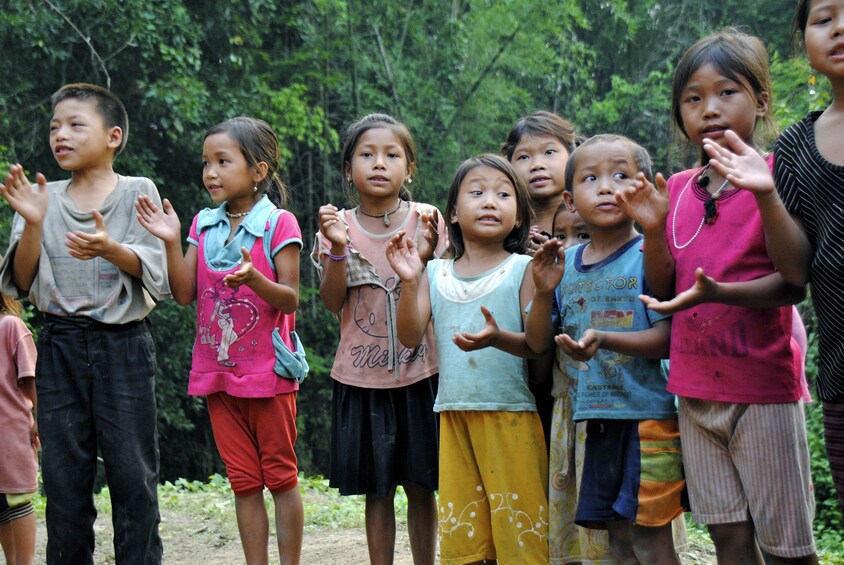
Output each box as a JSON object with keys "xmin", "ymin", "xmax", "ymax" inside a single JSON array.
[{"xmin": 564, "ymin": 142, "xmax": 639, "ymax": 229}]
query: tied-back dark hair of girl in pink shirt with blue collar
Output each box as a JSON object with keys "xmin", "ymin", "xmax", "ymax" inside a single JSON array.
[{"xmin": 203, "ymin": 116, "xmax": 288, "ymax": 208}]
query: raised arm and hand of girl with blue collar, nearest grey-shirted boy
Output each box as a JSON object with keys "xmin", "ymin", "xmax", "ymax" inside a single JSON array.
[{"xmin": 135, "ymin": 195, "xmax": 196, "ymax": 306}]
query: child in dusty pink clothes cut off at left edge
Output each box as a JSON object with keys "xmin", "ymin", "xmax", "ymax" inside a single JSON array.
[{"xmin": 0, "ymin": 294, "xmax": 40, "ymax": 565}]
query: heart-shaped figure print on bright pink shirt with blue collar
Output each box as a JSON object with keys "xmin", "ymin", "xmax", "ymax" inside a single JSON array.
[{"xmin": 199, "ymin": 279, "xmax": 258, "ymax": 367}]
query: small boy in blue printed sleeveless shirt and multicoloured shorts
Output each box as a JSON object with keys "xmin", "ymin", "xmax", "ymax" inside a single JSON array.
[{"xmin": 526, "ymin": 135, "xmax": 684, "ymax": 564}]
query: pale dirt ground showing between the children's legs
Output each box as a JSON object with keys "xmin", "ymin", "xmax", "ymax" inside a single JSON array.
[{"xmin": 35, "ymin": 507, "xmax": 413, "ymax": 565}]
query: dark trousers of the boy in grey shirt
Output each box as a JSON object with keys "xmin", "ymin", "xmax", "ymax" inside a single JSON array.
[{"xmin": 36, "ymin": 315, "xmax": 162, "ymax": 565}]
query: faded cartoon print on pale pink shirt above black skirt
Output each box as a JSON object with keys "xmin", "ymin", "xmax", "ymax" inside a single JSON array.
[{"xmin": 350, "ymin": 277, "xmax": 428, "ymax": 368}]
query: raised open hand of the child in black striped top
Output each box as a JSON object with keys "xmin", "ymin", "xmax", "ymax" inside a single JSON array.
[{"xmin": 703, "ymin": 130, "xmax": 776, "ymax": 194}]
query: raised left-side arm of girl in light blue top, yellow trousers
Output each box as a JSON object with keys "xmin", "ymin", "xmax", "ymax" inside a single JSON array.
[{"xmin": 386, "ymin": 231, "xmax": 431, "ymax": 348}]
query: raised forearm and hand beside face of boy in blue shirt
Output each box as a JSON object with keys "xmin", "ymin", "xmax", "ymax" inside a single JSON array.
[{"xmin": 615, "ymin": 173, "xmax": 674, "ymax": 298}]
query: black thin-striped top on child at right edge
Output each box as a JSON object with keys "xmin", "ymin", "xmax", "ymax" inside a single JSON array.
[{"xmin": 774, "ymin": 112, "xmax": 844, "ymax": 401}]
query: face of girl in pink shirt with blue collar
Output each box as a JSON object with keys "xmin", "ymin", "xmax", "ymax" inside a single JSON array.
[{"xmin": 202, "ymin": 133, "xmax": 263, "ymax": 207}]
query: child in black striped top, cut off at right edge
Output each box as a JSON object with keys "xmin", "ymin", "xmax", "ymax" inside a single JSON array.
[{"xmin": 713, "ymin": 0, "xmax": 844, "ymax": 512}]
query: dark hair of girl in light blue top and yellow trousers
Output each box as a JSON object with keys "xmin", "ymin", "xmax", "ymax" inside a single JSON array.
[{"xmin": 445, "ymin": 153, "xmax": 533, "ymax": 259}]
